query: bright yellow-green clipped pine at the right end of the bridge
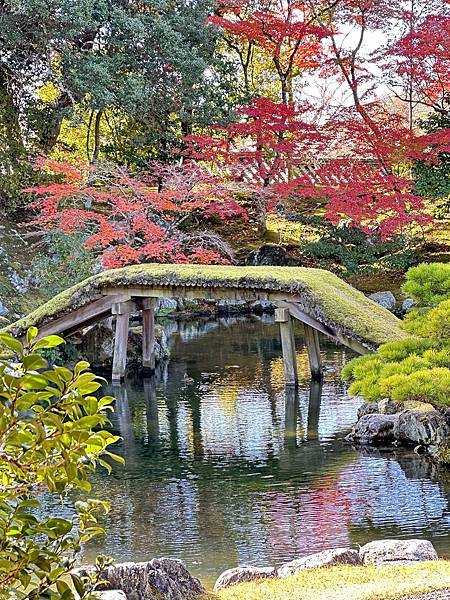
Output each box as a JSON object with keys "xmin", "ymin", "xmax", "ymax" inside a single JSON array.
[{"xmin": 342, "ymin": 263, "xmax": 450, "ymax": 406}]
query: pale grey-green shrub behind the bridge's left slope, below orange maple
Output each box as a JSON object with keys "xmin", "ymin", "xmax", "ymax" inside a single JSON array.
[{"xmin": 32, "ymin": 231, "xmax": 95, "ymax": 298}]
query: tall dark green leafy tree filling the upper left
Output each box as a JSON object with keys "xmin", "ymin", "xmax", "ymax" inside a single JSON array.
[{"xmin": 0, "ymin": 0, "xmax": 237, "ymax": 204}]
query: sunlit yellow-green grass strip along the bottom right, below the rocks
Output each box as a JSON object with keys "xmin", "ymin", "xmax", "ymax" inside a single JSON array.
[{"xmin": 205, "ymin": 560, "xmax": 450, "ymax": 600}]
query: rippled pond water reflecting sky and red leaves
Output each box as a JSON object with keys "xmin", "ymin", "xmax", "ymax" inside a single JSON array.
[{"xmin": 83, "ymin": 319, "xmax": 450, "ymax": 583}]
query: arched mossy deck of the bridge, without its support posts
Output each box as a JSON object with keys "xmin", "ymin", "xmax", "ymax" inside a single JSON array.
[{"xmin": 7, "ymin": 264, "xmax": 406, "ymax": 350}]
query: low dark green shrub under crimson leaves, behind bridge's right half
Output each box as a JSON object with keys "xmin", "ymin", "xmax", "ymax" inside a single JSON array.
[{"xmin": 290, "ymin": 216, "xmax": 416, "ymax": 275}]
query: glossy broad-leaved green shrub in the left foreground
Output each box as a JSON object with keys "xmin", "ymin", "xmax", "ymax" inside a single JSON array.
[{"xmin": 0, "ymin": 328, "xmax": 119, "ymax": 600}]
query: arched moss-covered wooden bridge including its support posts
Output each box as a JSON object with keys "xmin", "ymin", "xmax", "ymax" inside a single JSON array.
[{"xmin": 8, "ymin": 264, "xmax": 405, "ymax": 384}]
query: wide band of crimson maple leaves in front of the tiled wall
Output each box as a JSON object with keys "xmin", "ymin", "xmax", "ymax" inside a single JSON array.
[{"xmin": 186, "ymin": 98, "xmax": 450, "ymax": 238}]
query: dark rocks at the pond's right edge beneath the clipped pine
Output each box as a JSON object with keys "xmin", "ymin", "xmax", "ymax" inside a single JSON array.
[{"xmin": 346, "ymin": 399, "xmax": 450, "ymax": 462}]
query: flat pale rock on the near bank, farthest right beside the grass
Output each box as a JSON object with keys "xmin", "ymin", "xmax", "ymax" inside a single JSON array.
[{"xmin": 359, "ymin": 540, "xmax": 438, "ymax": 565}]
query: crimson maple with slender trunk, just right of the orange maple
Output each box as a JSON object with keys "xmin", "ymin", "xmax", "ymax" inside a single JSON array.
[{"xmin": 185, "ymin": 98, "xmax": 320, "ymax": 234}]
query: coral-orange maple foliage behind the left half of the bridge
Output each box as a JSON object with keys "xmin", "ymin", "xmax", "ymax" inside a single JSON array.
[{"xmin": 27, "ymin": 161, "xmax": 245, "ymax": 268}]
